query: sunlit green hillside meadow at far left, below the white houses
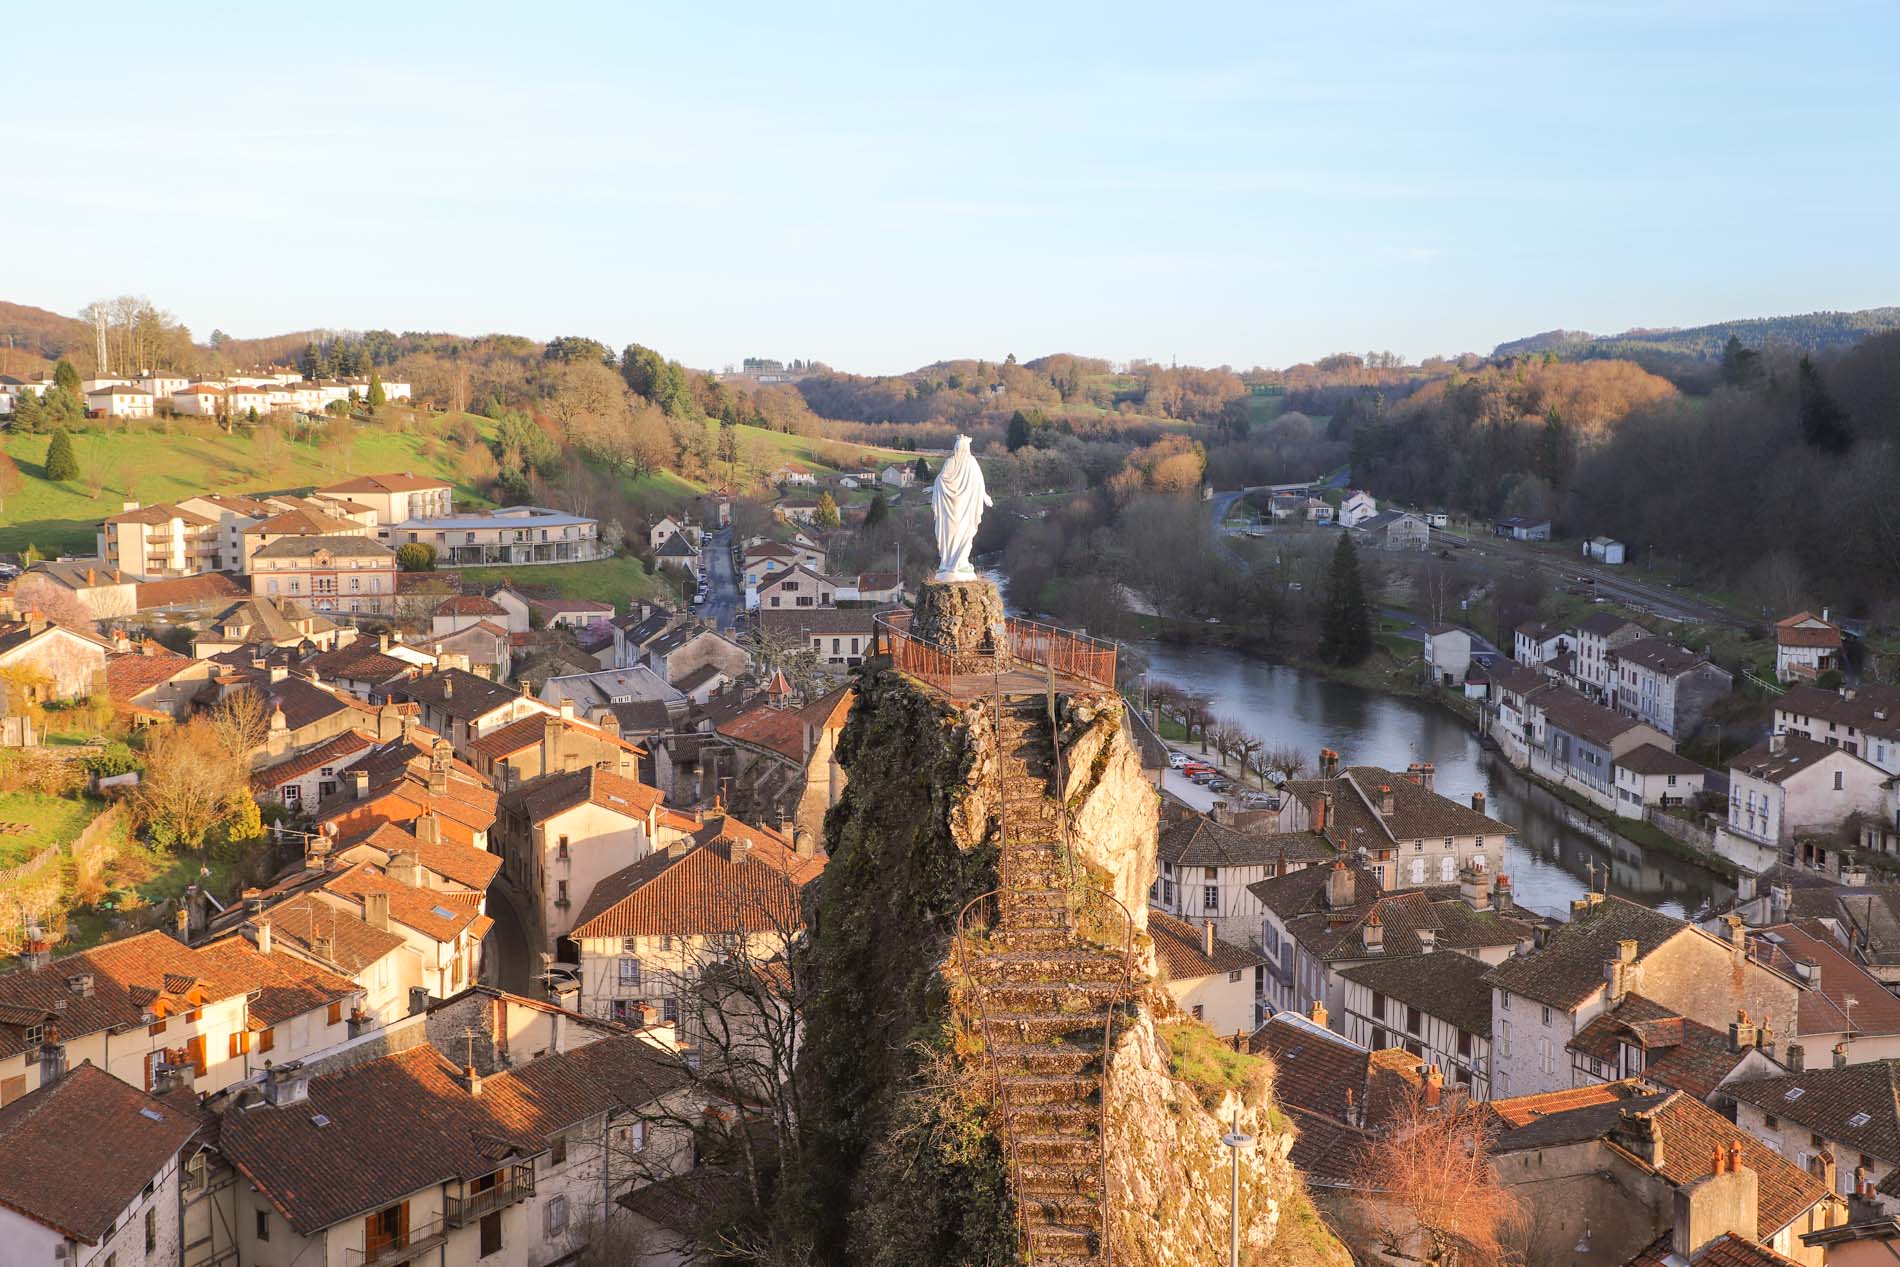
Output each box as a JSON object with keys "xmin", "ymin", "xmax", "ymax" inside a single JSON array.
[{"xmin": 0, "ymin": 420, "xmax": 492, "ymax": 555}]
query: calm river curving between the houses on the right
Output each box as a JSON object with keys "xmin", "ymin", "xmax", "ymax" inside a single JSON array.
[{"xmin": 1129, "ymin": 642, "xmax": 1735, "ymax": 916}]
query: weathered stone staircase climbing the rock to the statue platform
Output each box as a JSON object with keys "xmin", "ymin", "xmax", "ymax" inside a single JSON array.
[{"xmin": 965, "ymin": 695, "xmax": 1129, "ymax": 1267}]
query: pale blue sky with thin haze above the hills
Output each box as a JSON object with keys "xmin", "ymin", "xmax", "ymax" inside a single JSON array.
[{"xmin": 0, "ymin": 0, "xmax": 1900, "ymax": 372}]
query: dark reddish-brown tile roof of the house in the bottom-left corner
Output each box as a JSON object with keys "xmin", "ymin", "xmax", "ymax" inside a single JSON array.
[{"xmin": 0, "ymin": 1062, "xmax": 200, "ymax": 1256}]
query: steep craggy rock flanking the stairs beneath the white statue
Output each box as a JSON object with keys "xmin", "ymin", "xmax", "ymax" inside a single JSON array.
[{"xmin": 785, "ymin": 661, "xmax": 1345, "ymax": 1267}]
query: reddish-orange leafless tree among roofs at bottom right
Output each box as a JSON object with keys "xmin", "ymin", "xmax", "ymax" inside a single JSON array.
[{"xmin": 1357, "ymin": 1087, "xmax": 1522, "ymax": 1267}]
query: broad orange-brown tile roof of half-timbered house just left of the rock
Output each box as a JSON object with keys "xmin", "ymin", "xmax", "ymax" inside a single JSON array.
[{"xmin": 570, "ymin": 817, "xmax": 825, "ymax": 940}]
